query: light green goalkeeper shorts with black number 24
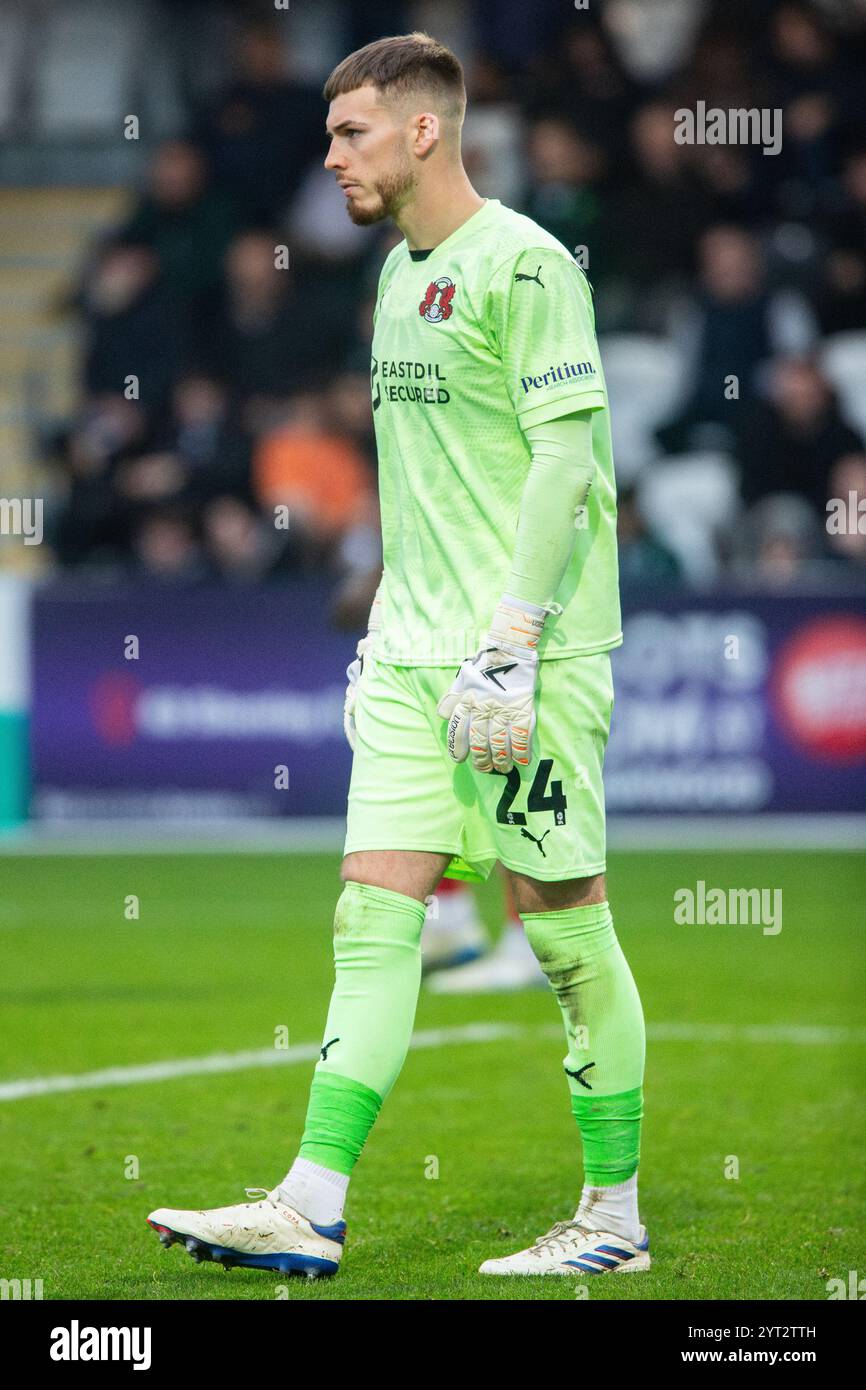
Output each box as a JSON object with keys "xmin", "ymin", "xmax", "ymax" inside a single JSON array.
[{"xmin": 343, "ymin": 652, "xmax": 613, "ymax": 883}]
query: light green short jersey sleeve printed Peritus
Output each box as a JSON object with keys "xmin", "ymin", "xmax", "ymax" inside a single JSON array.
[{"xmin": 484, "ymin": 246, "xmax": 606, "ymax": 427}]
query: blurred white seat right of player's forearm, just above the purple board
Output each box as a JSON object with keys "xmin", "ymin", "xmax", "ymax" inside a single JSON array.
[{"xmin": 638, "ymin": 453, "xmax": 740, "ymax": 584}]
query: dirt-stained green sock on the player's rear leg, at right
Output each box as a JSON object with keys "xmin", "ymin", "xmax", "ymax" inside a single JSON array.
[{"xmin": 520, "ymin": 902, "xmax": 646, "ymax": 1187}]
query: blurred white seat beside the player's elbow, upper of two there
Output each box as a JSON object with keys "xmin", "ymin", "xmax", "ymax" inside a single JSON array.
[{"xmin": 599, "ymin": 334, "xmax": 685, "ymax": 482}]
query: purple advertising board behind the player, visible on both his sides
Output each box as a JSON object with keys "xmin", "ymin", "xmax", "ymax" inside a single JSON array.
[{"xmin": 32, "ymin": 581, "xmax": 866, "ymax": 819}]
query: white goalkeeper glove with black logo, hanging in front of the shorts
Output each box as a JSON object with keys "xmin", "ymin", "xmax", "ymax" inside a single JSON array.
[{"xmin": 436, "ymin": 594, "xmax": 562, "ymax": 773}]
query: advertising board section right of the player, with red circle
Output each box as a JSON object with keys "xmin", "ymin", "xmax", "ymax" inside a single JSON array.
[{"xmin": 605, "ymin": 594, "xmax": 866, "ymax": 815}]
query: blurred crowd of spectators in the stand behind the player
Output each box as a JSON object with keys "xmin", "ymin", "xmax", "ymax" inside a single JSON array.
[{"xmin": 38, "ymin": 0, "xmax": 866, "ymax": 612}]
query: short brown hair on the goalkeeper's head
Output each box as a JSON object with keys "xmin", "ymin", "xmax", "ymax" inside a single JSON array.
[{"xmin": 321, "ymin": 31, "xmax": 466, "ymax": 131}]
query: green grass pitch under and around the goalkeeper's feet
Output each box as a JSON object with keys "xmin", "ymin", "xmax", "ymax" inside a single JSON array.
[{"xmin": 0, "ymin": 852, "xmax": 866, "ymax": 1301}]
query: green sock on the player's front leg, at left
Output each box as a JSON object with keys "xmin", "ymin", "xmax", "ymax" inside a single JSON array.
[{"xmin": 299, "ymin": 881, "xmax": 427, "ymax": 1173}]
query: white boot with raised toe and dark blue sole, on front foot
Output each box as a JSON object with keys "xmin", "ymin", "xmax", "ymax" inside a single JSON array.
[{"xmin": 147, "ymin": 1187, "xmax": 346, "ymax": 1279}]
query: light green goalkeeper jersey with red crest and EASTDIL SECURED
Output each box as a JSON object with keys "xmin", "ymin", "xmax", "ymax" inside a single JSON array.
[{"xmin": 371, "ymin": 197, "xmax": 621, "ymax": 666}]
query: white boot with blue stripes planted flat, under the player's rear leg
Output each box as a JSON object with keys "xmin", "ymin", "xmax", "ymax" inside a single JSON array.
[{"xmin": 478, "ymin": 1218, "xmax": 649, "ymax": 1275}]
